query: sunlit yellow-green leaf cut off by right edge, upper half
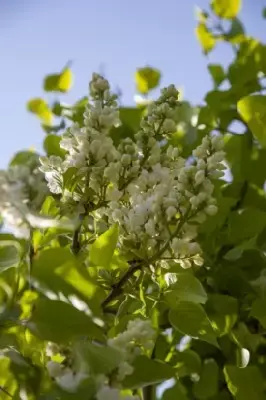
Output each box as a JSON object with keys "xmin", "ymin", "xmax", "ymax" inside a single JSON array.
[{"xmin": 237, "ymin": 95, "xmax": 266, "ymax": 147}]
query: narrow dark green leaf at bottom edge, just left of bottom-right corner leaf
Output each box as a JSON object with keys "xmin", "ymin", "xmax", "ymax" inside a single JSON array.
[{"xmin": 193, "ymin": 359, "xmax": 219, "ymax": 400}]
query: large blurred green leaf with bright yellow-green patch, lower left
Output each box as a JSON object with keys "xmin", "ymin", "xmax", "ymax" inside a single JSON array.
[{"xmin": 32, "ymin": 248, "xmax": 95, "ymax": 307}]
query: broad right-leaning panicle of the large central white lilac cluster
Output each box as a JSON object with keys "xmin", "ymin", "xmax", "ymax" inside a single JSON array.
[{"xmin": 107, "ymin": 136, "xmax": 224, "ymax": 267}]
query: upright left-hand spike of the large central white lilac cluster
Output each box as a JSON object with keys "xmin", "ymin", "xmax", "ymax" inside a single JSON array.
[{"xmin": 40, "ymin": 74, "xmax": 119, "ymax": 202}]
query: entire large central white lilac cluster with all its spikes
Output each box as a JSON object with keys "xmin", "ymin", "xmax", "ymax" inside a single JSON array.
[{"xmin": 40, "ymin": 74, "xmax": 225, "ymax": 267}]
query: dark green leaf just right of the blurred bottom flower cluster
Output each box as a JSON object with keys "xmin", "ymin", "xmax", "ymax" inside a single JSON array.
[{"xmin": 122, "ymin": 356, "xmax": 175, "ymax": 389}]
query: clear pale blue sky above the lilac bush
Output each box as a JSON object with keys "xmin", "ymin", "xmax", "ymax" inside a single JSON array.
[{"xmin": 0, "ymin": 0, "xmax": 266, "ymax": 168}]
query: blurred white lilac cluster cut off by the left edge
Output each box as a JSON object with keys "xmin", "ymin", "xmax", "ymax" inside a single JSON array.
[{"xmin": 0, "ymin": 165, "xmax": 48, "ymax": 237}]
